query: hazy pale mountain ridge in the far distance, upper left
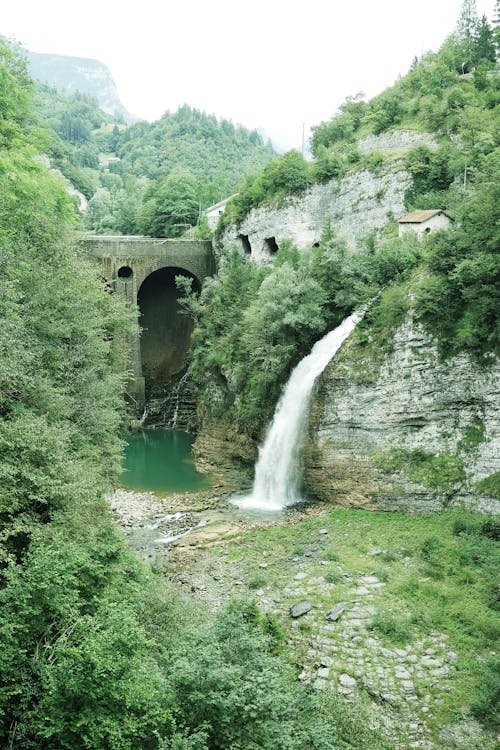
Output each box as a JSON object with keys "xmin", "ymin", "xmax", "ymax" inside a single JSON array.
[{"xmin": 26, "ymin": 51, "xmax": 139, "ymax": 123}]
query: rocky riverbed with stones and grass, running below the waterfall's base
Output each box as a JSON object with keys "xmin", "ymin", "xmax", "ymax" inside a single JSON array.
[{"xmin": 110, "ymin": 490, "xmax": 495, "ymax": 750}]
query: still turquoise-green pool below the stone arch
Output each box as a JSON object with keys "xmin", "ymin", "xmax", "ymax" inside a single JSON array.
[{"xmin": 120, "ymin": 430, "xmax": 209, "ymax": 493}]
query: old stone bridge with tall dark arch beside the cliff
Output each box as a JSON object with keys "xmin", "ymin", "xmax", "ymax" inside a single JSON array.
[{"xmin": 81, "ymin": 235, "xmax": 215, "ymax": 411}]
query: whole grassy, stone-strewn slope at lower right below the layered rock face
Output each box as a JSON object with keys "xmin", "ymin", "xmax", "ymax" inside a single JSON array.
[{"xmin": 170, "ymin": 510, "xmax": 500, "ymax": 749}]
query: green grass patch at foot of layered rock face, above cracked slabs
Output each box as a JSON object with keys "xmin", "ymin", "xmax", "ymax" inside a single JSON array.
[{"xmin": 185, "ymin": 509, "xmax": 500, "ymax": 750}]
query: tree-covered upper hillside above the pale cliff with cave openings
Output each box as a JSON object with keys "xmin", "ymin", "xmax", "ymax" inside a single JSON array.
[{"xmin": 219, "ymin": 7, "xmax": 500, "ymax": 232}]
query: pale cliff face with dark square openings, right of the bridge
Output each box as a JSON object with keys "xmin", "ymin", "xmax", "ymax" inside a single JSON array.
[{"xmin": 218, "ymin": 167, "xmax": 411, "ymax": 263}]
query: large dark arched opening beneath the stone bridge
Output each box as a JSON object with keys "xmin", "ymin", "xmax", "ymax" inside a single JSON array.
[{"xmin": 137, "ymin": 268, "xmax": 201, "ymax": 398}]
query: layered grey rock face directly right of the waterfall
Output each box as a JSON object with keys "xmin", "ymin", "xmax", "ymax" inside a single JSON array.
[{"xmin": 305, "ymin": 316, "xmax": 500, "ymax": 512}]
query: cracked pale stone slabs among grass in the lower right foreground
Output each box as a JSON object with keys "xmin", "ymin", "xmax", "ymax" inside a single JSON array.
[{"xmin": 172, "ymin": 554, "xmax": 464, "ymax": 750}]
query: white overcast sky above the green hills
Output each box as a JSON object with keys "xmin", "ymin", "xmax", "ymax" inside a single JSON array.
[{"xmin": 0, "ymin": 0, "xmax": 494, "ymax": 148}]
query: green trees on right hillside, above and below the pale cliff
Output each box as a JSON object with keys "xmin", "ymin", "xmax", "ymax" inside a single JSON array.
[{"xmin": 186, "ymin": 3, "xmax": 500, "ymax": 437}]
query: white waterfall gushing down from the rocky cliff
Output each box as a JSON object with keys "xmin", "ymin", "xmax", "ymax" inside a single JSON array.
[{"xmin": 233, "ymin": 309, "xmax": 364, "ymax": 511}]
